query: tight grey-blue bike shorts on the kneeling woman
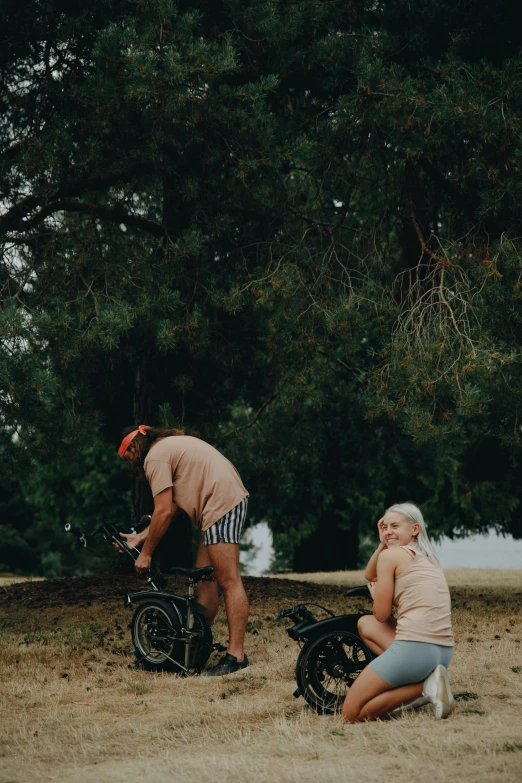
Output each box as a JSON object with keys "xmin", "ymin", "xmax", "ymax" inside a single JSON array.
[{"xmin": 370, "ymin": 640, "xmax": 453, "ymax": 688}]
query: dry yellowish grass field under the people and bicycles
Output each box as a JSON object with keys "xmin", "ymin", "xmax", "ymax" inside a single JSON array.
[{"xmin": 0, "ymin": 571, "xmax": 522, "ymax": 783}]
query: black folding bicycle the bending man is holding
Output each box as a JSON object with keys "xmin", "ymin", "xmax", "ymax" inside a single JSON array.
[{"xmin": 65, "ymin": 515, "xmax": 219, "ymax": 676}]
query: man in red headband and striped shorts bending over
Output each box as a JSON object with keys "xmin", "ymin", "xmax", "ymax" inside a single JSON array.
[{"xmin": 118, "ymin": 424, "xmax": 249, "ymax": 677}]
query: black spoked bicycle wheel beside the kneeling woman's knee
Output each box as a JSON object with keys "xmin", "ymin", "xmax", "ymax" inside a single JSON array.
[{"xmin": 295, "ymin": 631, "xmax": 373, "ymax": 715}]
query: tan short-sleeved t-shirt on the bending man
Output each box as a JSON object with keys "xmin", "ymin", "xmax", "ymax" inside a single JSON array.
[{"xmin": 143, "ymin": 435, "xmax": 248, "ymax": 530}]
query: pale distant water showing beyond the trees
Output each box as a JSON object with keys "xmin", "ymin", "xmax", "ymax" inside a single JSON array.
[{"xmin": 243, "ymin": 522, "xmax": 522, "ymax": 576}]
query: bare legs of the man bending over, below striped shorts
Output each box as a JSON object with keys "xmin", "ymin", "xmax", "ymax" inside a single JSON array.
[{"xmin": 196, "ymin": 541, "xmax": 249, "ymax": 661}]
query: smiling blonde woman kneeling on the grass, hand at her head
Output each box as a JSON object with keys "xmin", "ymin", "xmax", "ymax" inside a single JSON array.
[{"xmin": 343, "ymin": 503, "xmax": 454, "ymax": 723}]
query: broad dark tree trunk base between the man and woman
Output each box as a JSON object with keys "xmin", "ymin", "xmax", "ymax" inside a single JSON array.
[{"xmin": 292, "ymin": 516, "xmax": 359, "ymax": 573}]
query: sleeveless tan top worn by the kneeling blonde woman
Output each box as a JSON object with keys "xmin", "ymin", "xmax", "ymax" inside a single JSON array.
[{"xmin": 393, "ymin": 546, "xmax": 455, "ymax": 647}]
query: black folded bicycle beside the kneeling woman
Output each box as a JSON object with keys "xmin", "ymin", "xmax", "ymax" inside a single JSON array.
[{"xmin": 276, "ymin": 585, "xmax": 375, "ymax": 715}]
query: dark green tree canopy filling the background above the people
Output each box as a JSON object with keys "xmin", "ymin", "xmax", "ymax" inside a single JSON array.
[{"xmin": 0, "ymin": 0, "xmax": 522, "ymax": 576}]
